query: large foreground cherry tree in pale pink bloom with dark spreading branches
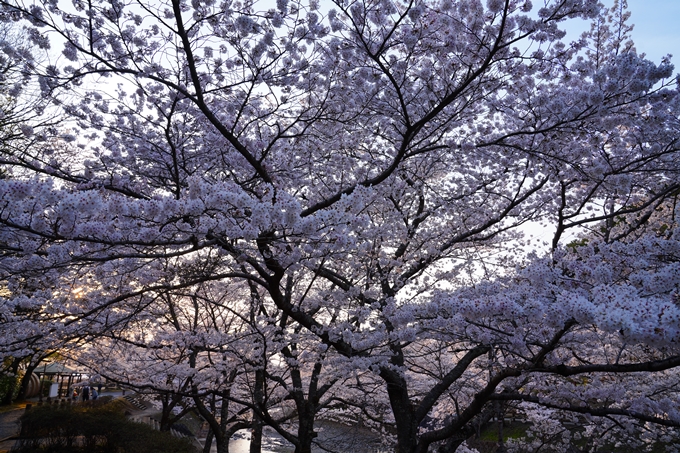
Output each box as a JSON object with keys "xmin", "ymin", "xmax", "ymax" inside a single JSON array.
[{"xmin": 0, "ymin": 0, "xmax": 680, "ymax": 453}]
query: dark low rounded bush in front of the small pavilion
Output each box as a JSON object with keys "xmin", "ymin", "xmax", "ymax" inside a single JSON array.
[{"xmin": 12, "ymin": 402, "xmax": 196, "ymax": 453}]
